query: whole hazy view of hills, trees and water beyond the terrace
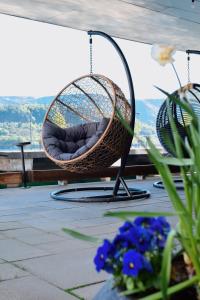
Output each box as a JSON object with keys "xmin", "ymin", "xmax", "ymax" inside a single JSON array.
[{"xmin": 0, "ymin": 94, "xmax": 163, "ymax": 150}]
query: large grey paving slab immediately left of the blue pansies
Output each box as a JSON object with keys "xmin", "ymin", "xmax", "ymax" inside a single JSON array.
[{"xmin": 16, "ymin": 247, "xmax": 108, "ymax": 289}]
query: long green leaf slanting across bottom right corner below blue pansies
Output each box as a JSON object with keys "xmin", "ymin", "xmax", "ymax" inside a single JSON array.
[{"xmin": 140, "ymin": 275, "xmax": 200, "ymax": 300}]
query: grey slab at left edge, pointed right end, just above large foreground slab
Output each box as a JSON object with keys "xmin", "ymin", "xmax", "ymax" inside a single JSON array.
[{"xmin": 0, "ymin": 239, "xmax": 49, "ymax": 261}]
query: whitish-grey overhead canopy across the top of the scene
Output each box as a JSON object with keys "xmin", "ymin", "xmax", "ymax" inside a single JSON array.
[{"xmin": 0, "ymin": 0, "xmax": 200, "ymax": 50}]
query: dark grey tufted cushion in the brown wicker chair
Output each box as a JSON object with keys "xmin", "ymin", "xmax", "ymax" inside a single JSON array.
[{"xmin": 43, "ymin": 118, "xmax": 109, "ymax": 160}]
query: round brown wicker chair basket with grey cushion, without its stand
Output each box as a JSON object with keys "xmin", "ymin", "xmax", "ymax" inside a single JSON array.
[{"xmin": 42, "ymin": 74, "xmax": 131, "ymax": 173}]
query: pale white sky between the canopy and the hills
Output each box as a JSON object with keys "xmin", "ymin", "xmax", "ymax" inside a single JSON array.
[{"xmin": 0, "ymin": 14, "xmax": 200, "ymax": 99}]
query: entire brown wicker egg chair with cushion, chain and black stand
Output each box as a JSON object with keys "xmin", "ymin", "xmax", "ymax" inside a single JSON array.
[{"xmin": 42, "ymin": 31, "xmax": 150, "ymax": 202}]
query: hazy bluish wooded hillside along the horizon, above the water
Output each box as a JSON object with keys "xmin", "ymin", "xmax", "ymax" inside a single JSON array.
[{"xmin": 0, "ymin": 95, "xmax": 163, "ymax": 127}]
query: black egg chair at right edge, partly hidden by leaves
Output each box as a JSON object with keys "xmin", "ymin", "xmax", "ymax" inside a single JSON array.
[{"xmin": 154, "ymin": 50, "xmax": 200, "ymax": 190}]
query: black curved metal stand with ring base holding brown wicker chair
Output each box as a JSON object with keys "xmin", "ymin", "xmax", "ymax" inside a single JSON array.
[{"xmin": 51, "ymin": 31, "xmax": 150, "ymax": 202}]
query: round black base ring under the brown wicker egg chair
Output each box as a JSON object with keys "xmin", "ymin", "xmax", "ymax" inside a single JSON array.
[{"xmin": 51, "ymin": 187, "xmax": 150, "ymax": 203}]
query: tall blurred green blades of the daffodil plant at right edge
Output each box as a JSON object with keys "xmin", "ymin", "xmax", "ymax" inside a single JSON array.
[{"xmin": 147, "ymin": 91, "xmax": 200, "ymax": 300}]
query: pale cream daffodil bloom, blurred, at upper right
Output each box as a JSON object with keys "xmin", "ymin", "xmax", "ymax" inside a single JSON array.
[{"xmin": 151, "ymin": 44, "xmax": 176, "ymax": 66}]
